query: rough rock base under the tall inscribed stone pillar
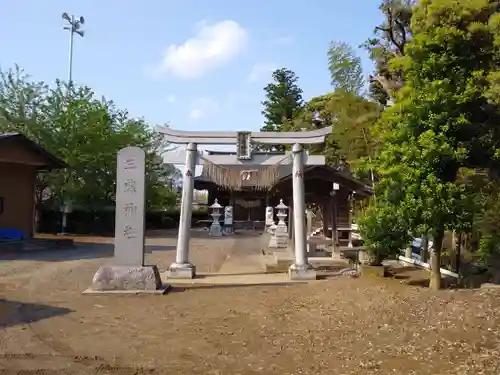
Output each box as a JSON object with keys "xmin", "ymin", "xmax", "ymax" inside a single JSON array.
[{"xmin": 83, "ymin": 265, "xmax": 170, "ymax": 294}]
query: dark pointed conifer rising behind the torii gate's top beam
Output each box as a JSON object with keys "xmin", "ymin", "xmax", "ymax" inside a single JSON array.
[{"xmin": 261, "ymin": 68, "xmax": 304, "ymax": 151}]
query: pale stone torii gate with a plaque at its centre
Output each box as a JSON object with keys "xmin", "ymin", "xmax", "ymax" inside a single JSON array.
[{"xmin": 157, "ymin": 126, "xmax": 332, "ymax": 280}]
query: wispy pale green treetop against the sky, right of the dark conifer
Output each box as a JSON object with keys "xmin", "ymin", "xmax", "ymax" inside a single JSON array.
[{"xmin": 328, "ymin": 41, "xmax": 364, "ymax": 95}]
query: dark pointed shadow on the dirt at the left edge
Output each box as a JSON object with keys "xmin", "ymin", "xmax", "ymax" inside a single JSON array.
[{"xmin": 0, "ymin": 299, "xmax": 73, "ymax": 328}]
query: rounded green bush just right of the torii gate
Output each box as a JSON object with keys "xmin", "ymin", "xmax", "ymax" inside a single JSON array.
[{"xmin": 359, "ymin": 204, "xmax": 411, "ymax": 266}]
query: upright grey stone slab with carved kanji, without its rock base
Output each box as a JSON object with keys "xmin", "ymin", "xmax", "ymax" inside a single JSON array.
[{"xmin": 115, "ymin": 147, "xmax": 145, "ymax": 267}]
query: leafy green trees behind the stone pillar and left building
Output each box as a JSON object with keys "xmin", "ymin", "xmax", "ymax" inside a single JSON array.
[{"xmin": 0, "ymin": 68, "xmax": 175, "ymax": 216}]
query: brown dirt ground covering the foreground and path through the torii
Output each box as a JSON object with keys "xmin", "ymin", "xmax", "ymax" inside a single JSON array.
[{"xmin": 0, "ymin": 234, "xmax": 500, "ymax": 375}]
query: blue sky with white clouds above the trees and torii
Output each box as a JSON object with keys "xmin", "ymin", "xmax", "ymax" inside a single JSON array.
[{"xmin": 0, "ymin": 0, "xmax": 381, "ymax": 139}]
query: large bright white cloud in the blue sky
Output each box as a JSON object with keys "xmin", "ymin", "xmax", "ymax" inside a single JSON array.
[{"xmin": 161, "ymin": 20, "xmax": 249, "ymax": 79}]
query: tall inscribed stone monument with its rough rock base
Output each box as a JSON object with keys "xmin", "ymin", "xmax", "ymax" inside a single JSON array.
[{"xmin": 84, "ymin": 147, "xmax": 168, "ymax": 294}]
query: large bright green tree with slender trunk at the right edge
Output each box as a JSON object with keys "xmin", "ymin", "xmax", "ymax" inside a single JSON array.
[{"xmin": 366, "ymin": 0, "xmax": 500, "ymax": 288}]
